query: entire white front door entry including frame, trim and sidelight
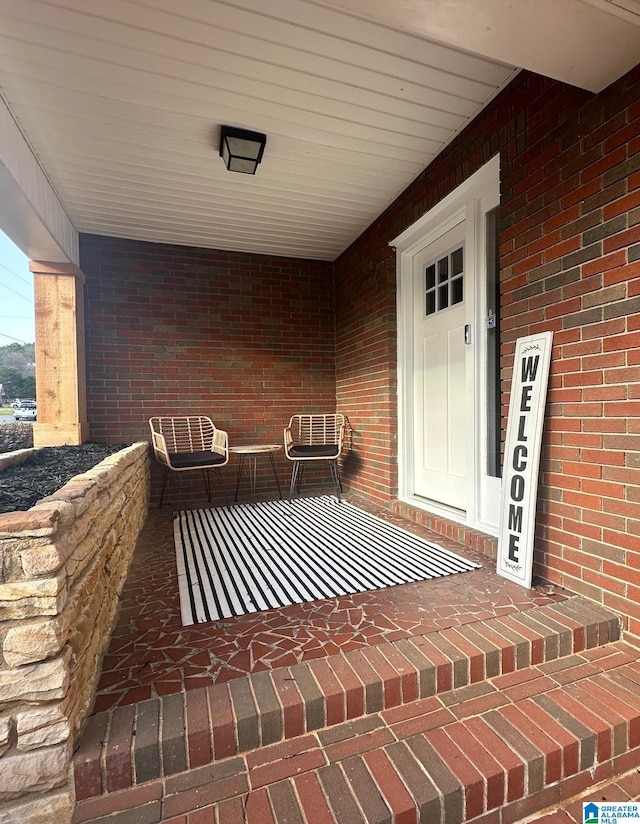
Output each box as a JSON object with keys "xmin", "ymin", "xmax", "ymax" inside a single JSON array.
[{"xmin": 392, "ymin": 156, "xmax": 500, "ymax": 534}]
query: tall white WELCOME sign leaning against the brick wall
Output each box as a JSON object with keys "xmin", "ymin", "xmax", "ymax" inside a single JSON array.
[{"xmin": 497, "ymin": 332, "xmax": 553, "ymax": 588}]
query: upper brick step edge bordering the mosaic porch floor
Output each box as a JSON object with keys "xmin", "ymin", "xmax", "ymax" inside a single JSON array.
[{"xmin": 74, "ymin": 596, "xmax": 621, "ymax": 800}]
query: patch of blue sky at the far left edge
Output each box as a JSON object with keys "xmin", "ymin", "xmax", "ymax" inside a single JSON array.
[{"xmin": 0, "ymin": 231, "xmax": 35, "ymax": 346}]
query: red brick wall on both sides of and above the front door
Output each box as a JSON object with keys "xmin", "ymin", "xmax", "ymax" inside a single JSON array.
[{"xmin": 336, "ymin": 67, "xmax": 640, "ymax": 635}]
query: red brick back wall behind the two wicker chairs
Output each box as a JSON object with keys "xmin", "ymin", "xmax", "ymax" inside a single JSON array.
[{"xmin": 80, "ymin": 235, "xmax": 335, "ymax": 500}]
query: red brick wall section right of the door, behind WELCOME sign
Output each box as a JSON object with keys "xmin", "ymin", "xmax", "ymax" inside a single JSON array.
[{"xmin": 501, "ymin": 69, "xmax": 640, "ymax": 635}]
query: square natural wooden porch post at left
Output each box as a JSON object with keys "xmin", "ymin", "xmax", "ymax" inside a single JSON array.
[{"xmin": 29, "ymin": 261, "xmax": 89, "ymax": 446}]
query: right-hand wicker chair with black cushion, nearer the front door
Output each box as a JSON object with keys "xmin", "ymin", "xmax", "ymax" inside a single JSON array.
[{"xmin": 284, "ymin": 415, "xmax": 344, "ymax": 500}]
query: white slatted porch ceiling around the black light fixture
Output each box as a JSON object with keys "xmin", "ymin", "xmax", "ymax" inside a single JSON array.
[{"xmin": 0, "ymin": 0, "xmax": 640, "ymax": 260}]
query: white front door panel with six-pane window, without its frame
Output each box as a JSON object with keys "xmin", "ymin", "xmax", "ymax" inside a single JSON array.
[{"xmin": 412, "ymin": 222, "xmax": 468, "ymax": 510}]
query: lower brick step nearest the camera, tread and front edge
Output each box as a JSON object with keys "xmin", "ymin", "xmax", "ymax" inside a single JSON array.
[{"xmin": 73, "ymin": 641, "xmax": 640, "ymax": 824}]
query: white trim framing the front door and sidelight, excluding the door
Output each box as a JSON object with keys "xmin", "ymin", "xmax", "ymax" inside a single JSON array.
[{"xmin": 389, "ymin": 155, "xmax": 500, "ymax": 534}]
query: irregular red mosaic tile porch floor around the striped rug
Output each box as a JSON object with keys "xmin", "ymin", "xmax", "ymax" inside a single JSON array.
[{"xmin": 94, "ymin": 500, "xmax": 567, "ymax": 712}]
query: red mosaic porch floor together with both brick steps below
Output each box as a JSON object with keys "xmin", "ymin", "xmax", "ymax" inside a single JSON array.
[{"xmin": 74, "ymin": 492, "xmax": 640, "ymax": 824}]
